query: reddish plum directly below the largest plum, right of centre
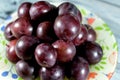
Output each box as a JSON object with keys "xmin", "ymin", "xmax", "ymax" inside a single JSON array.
[{"xmin": 52, "ymin": 40, "xmax": 76, "ymax": 62}]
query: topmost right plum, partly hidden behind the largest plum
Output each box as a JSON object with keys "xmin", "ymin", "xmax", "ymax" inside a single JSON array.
[{"xmin": 58, "ymin": 2, "xmax": 82, "ymax": 23}]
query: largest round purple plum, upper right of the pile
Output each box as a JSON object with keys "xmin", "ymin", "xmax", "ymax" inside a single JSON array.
[{"xmin": 54, "ymin": 14, "xmax": 80, "ymax": 41}]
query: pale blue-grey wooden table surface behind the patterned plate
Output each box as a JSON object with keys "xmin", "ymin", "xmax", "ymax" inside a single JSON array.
[{"xmin": 0, "ymin": 0, "xmax": 120, "ymax": 80}]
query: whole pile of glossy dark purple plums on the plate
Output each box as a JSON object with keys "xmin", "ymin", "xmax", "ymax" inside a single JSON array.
[{"xmin": 4, "ymin": 1, "xmax": 103, "ymax": 80}]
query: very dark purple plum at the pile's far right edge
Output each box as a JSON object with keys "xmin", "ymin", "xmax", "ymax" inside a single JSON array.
[{"xmin": 76, "ymin": 41, "xmax": 103, "ymax": 64}]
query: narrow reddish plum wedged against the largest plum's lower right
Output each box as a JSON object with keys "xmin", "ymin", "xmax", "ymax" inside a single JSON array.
[{"xmin": 72, "ymin": 25, "xmax": 88, "ymax": 46}]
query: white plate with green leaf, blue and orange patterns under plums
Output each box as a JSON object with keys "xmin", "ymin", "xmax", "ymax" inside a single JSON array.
[{"xmin": 0, "ymin": 3, "xmax": 118, "ymax": 80}]
